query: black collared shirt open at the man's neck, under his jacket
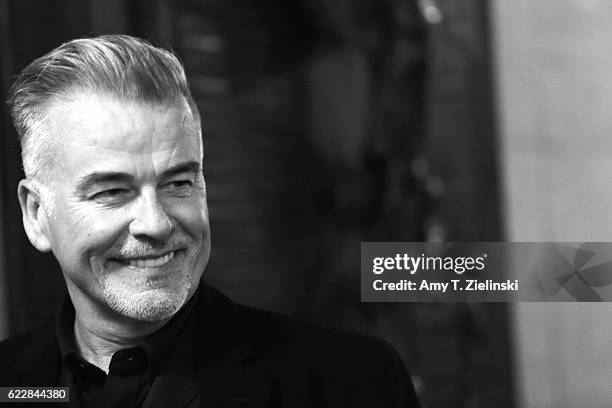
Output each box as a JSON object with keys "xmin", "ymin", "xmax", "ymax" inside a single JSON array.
[{"xmin": 56, "ymin": 290, "xmax": 199, "ymax": 408}]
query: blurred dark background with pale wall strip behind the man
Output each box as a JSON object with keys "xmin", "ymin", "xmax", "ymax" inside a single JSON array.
[{"xmin": 0, "ymin": 0, "xmax": 612, "ymax": 408}]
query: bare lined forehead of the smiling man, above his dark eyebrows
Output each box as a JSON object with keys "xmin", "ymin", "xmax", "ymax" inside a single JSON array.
[{"xmin": 45, "ymin": 94, "xmax": 202, "ymax": 178}]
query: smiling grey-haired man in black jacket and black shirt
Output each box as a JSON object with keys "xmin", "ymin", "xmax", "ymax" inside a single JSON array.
[{"xmin": 0, "ymin": 35, "xmax": 417, "ymax": 407}]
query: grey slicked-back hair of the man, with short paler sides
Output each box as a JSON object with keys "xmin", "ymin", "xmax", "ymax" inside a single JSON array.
[{"xmin": 8, "ymin": 35, "xmax": 200, "ymax": 179}]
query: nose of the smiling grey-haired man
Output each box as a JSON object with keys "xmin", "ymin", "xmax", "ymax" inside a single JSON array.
[{"xmin": 129, "ymin": 189, "xmax": 172, "ymax": 240}]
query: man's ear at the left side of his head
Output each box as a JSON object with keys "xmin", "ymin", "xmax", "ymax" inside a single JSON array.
[{"xmin": 17, "ymin": 180, "xmax": 51, "ymax": 252}]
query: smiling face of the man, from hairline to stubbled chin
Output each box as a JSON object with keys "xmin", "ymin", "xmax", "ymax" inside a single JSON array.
[{"xmin": 32, "ymin": 94, "xmax": 210, "ymax": 321}]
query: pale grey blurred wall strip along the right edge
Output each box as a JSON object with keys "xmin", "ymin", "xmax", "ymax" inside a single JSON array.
[{"xmin": 493, "ymin": 0, "xmax": 612, "ymax": 407}]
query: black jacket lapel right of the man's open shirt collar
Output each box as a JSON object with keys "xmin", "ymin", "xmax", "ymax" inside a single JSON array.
[{"xmin": 196, "ymin": 286, "xmax": 270, "ymax": 408}]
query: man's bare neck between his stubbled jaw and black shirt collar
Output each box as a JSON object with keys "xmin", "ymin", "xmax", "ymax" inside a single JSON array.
[{"xmin": 71, "ymin": 296, "xmax": 170, "ymax": 374}]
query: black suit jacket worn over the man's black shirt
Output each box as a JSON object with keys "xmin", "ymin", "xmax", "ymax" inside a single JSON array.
[{"xmin": 0, "ymin": 286, "xmax": 418, "ymax": 408}]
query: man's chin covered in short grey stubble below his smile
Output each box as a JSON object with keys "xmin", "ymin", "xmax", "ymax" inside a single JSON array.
[{"xmin": 103, "ymin": 279, "xmax": 191, "ymax": 322}]
